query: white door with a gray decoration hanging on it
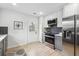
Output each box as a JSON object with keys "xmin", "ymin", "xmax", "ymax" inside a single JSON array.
[{"xmin": 28, "ymin": 18, "xmax": 39, "ymax": 43}]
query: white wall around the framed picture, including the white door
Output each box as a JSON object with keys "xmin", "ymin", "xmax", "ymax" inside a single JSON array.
[{"xmin": 0, "ymin": 9, "xmax": 39, "ymax": 48}]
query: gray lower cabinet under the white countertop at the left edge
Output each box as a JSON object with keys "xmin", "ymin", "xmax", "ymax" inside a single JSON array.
[{"xmin": 0, "ymin": 36, "xmax": 7, "ymax": 56}]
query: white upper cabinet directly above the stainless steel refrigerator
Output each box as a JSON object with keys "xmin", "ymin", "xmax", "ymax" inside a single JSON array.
[{"xmin": 63, "ymin": 3, "xmax": 77, "ymax": 17}]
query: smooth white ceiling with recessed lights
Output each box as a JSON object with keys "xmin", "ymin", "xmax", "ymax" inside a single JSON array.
[{"xmin": 0, "ymin": 3, "xmax": 67, "ymax": 16}]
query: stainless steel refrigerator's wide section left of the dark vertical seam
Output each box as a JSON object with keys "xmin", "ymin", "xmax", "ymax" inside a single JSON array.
[{"xmin": 62, "ymin": 15, "xmax": 75, "ymax": 56}]
